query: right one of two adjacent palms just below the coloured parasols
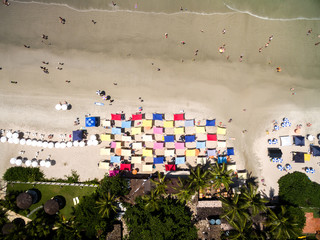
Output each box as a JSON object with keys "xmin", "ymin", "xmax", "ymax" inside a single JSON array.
[{"xmin": 210, "ymin": 163, "xmax": 233, "ymax": 190}]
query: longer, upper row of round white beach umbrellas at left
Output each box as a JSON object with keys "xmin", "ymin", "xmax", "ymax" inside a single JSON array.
[{"xmin": 0, "ymin": 136, "xmax": 99, "ymax": 148}]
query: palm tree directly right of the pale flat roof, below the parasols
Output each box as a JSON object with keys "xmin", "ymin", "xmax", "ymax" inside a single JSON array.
[{"xmin": 220, "ymin": 193, "xmax": 250, "ymax": 221}]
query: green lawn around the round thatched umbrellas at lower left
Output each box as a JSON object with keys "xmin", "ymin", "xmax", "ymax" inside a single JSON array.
[{"xmin": 7, "ymin": 183, "xmax": 96, "ymax": 219}]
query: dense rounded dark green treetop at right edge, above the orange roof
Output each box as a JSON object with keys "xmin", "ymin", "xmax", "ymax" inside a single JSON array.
[{"xmin": 278, "ymin": 172, "xmax": 320, "ymax": 208}]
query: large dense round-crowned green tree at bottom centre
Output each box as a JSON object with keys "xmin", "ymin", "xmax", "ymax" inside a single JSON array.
[{"xmin": 124, "ymin": 196, "xmax": 197, "ymax": 240}]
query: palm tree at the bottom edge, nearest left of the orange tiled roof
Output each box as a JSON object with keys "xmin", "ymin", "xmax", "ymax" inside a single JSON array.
[{"xmin": 266, "ymin": 206, "xmax": 300, "ymax": 240}]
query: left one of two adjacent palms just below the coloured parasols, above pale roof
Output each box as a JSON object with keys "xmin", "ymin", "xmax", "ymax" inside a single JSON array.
[{"xmin": 189, "ymin": 165, "xmax": 209, "ymax": 192}]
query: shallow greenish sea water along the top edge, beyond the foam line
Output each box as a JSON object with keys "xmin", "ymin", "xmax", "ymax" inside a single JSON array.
[{"xmin": 12, "ymin": 0, "xmax": 320, "ymax": 21}]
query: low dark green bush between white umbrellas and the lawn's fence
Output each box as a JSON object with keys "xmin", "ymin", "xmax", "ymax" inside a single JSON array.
[{"xmin": 3, "ymin": 167, "xmax": 44, "ymax": 182}]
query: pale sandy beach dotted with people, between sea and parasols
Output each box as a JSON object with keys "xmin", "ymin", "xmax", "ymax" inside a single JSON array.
[{"xmin": 0, "ymin": 2, "xmax": 320, "ymax": 194}]
